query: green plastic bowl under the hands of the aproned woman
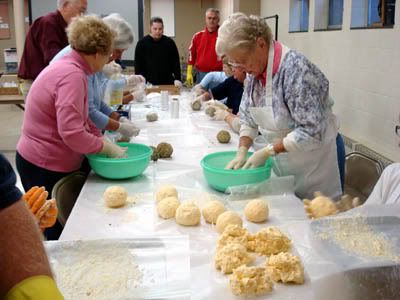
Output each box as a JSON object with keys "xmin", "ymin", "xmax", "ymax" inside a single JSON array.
[{"xmin": 200, "ymin": 151, "xmax": 273, "ymax": 192}]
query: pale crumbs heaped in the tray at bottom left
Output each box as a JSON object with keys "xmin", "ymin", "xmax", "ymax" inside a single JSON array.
[{"xmin": 52, "ymin": 245, "xmax": 143, "ymax": 300}]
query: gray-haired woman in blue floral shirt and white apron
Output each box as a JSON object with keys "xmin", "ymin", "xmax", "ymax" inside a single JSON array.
[{"xmin": 216, "ymin": 13, "xmax": 342, "ymax": 198}]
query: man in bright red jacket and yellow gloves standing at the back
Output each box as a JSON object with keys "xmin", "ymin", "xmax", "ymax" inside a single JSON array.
[{"xmin": 186, "ymin": 8, "xmax": 222, "ymax": 86}]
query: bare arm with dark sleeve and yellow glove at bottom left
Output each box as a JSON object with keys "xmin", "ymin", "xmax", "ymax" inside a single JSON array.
[{"xmin": 0, "ymin": 155, "xmax": 63, "ymax": 300}]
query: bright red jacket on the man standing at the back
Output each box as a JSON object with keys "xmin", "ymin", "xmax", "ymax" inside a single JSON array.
[{"xmin": 188, "ymin": 28, "xmax": 222, "ymax": 72}]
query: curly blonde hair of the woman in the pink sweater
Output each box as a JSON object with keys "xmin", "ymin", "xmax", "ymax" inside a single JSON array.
[{"xmin": 67, "ymin": 15, "xmax": 116, "ymax": 55}]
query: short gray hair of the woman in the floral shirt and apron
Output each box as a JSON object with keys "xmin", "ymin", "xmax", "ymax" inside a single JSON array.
[{"xmin": 215, "ymin": 13, "xmax": 272, "ymax": 57}]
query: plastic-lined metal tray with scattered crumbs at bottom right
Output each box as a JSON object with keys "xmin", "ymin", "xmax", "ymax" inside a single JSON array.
[{"xmin": 286, "ymin": 204, "xmax": 400, "ymax": 300}]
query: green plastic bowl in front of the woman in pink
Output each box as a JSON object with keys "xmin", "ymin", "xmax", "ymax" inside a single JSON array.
[{"xmin": 87, "ymin": 143, "xmax": 152, "ymax": 179}]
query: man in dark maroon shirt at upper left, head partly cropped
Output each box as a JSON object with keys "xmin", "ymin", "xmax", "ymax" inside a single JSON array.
[{"xmin": 18, "ymin": 0, "xmax": 87, "ymax": 94}]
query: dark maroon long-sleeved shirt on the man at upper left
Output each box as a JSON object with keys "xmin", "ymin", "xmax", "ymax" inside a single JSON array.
[{"xmin": 18, "ymin": 11, "xmax": 68, "ymax": 80}]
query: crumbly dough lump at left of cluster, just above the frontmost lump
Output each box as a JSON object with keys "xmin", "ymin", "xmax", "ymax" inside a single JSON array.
[{"xmin": 214, "ymin": 243, "xmax": 254, "ymax": 274}]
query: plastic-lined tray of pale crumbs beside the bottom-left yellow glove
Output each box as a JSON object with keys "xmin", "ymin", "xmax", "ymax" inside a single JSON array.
[{"xmin": 45, "ymin": 236, "xmax": 190, "ymax": 300}]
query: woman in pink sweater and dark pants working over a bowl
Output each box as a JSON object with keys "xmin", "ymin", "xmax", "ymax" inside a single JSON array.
[{"xmin": 16, "ymin": 16, "xmax": 126, "ymax": 238}]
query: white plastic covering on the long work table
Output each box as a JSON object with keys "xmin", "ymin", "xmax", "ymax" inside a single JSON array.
[{"xmin": 60, "ymin": 93, "xmax": 400, "ymax": 299}]
